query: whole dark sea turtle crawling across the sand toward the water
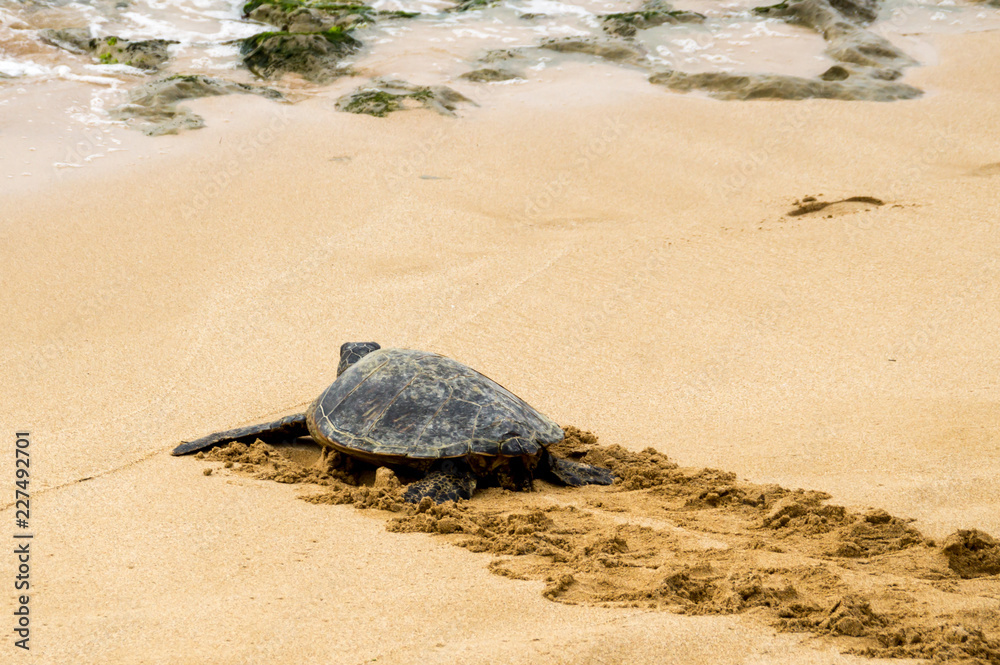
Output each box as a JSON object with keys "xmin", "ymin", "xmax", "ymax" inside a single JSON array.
[{"xmin": 173, "ymin": 342, "xmax": 614, "ymax": 503}]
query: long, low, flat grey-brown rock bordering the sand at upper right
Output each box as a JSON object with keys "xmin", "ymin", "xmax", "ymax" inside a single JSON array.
[{"xmin": 649, "ymin": 71, "xmax": 923, "ymax": 102}]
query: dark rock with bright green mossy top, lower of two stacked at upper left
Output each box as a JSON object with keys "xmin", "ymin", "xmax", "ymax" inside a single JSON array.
[{"xmin": 240, "ymin": 27, "xmax": 361, "ymax": 83}]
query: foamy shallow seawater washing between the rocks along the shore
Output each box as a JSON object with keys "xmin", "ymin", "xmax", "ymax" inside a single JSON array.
[{"xmin": 0, "ymin": 0, "xmax": 1000, "ymax": 177}]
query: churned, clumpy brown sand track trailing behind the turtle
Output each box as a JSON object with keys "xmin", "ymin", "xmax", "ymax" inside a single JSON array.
[{"xmin": 191, "ymin": 427, "xmax": 1000, "ymax": 664}]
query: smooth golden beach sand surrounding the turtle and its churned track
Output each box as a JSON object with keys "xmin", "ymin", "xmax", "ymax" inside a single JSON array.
[{"xmin": 0, "ymin": 33, "xmax": 1000, "ymax": 664}]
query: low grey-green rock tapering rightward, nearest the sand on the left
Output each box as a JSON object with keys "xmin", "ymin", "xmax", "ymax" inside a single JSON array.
[{"xmin": 111, "ymin": 74, "xmax": 282, "ymax": 136}]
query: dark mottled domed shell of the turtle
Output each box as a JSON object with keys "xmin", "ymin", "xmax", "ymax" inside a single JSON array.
[{"xmin": 306, "ymin": 349, "xmax": 563, "ymax": 466}]
